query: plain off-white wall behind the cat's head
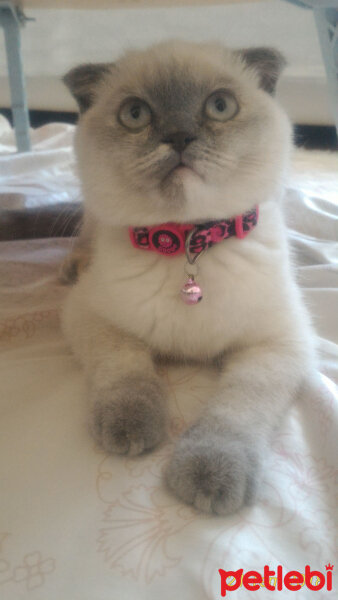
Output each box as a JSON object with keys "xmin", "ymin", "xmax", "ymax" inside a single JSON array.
[{"xmin": 0, "ymin": 0, "xmax": 333, "ymax": 123}]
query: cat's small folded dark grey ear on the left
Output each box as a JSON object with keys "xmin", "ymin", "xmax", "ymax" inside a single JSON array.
[{"xmin": 63, "ymin": 63, "xmax": 113, "ymax": 113}]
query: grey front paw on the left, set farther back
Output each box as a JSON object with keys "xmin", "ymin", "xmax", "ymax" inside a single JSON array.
[{"xmin": 91, "ymin": 377, "xmax": 166, "ymax": 456}]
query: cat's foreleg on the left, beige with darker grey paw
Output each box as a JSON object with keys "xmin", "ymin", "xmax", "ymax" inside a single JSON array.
[{"xmin": 62, "ymin": 285, "xmax": 166, "ymax": 455}]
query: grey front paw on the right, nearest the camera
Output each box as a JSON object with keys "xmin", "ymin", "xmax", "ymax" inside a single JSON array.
[{"xmin": 165, "ymin": 429, "xmax": 260, "ymax": 515}]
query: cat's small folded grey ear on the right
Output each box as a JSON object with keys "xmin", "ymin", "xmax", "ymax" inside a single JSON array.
[{"xmin": 237, "ymin": 47, "xmax": 286, "ymax": 94}]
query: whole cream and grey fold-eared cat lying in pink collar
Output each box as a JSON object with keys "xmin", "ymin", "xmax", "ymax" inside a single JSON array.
[{"xmin": 62, "ymin": 41, "xmax": 315, "ymax": 515}]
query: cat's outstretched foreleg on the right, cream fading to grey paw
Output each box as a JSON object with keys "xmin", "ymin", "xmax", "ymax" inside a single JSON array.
[{"xmin": 166, "ymin": 340, "xmax": 309, "ymax": 514}]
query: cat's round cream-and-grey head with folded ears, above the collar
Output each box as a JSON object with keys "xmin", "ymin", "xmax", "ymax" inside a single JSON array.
[{"xmin": 64, "ymin": 41, "xmax": 290, "ymax": 226}]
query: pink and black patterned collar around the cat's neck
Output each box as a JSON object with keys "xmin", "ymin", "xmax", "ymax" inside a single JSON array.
[{"xmin": 129, "ymin": 205, "xmax": 258, "ymax": 256}]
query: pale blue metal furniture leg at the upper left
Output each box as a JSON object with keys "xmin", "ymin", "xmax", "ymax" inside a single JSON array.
[{"xmin": 0, "ymin": 2, "xmax": 31, "ymax": 152}]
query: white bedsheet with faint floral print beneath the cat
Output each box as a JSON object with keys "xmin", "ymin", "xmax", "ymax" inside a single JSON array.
[{"xmin": 0, "ymin": 124, "xmax": 338, "ymax": 600}]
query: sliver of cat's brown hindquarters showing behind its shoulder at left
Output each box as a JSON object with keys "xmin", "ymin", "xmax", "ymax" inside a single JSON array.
[{"xmin": 60, "ymin": 212, "xmax": 95, "ymax": 284}]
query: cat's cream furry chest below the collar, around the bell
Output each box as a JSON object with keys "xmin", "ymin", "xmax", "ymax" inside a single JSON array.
[{"xmin": 88, "ymin": 236, "xmax": 264, "ymax": 359}]
